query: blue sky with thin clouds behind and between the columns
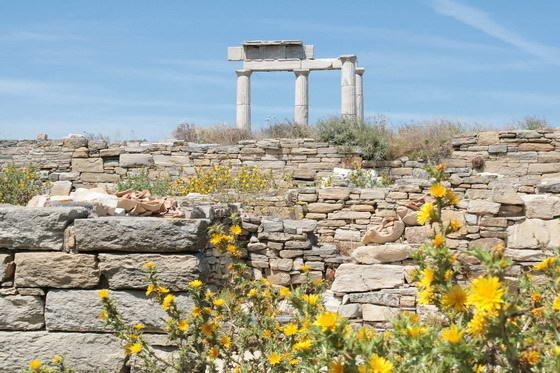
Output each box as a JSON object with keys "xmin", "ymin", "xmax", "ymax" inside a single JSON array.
[{"xmin": 0, "ymin": 0, "xmax": 560, "ymax": 140}]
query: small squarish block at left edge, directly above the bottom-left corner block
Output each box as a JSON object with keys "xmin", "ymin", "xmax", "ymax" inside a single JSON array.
[{"xmin": 0, "ymin": 295, "xmax": 44, "ymax": 328}]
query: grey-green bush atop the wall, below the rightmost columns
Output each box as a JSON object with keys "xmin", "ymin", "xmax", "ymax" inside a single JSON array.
[{"xmin": 317, "ymin": 117, "xmax": 388, "ymax": 160}]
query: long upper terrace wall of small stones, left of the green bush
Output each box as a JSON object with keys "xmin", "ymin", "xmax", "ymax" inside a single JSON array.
[{"xmin": 0, "ymin": 137, "xmax": 361, "ymax": 186}]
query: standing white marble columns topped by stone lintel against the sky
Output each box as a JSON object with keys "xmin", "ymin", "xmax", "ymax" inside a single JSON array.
[{"xmin": 228, "ymin": 40, "xmax": 365, "ymax": 131}]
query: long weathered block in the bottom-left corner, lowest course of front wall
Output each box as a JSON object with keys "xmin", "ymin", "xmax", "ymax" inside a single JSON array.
[{"xmin": 0, "ymin": 331, "xmax": 125, "ymax": 373}]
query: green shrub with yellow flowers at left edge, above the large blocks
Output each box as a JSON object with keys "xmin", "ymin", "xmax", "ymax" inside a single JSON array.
[{"xmin": 0, "ymin": 163, "xmax": 49, "ymax": 205}]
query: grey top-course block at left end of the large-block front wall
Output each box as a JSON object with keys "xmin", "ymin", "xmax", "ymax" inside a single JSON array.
[{"xmin": 0, "ymin": 206, "xmax": 89, "ymax": 250}]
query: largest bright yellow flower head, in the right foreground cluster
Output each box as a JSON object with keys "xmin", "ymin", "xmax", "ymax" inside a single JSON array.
[{"xmin": 467, "ymin": 277, "xmax": 504, "ymax": 313}]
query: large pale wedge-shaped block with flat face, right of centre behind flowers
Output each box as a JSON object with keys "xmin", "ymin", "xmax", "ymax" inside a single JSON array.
[{"xmin": 331, "ymin": 263, "xmax": 404, "ymax": 293}]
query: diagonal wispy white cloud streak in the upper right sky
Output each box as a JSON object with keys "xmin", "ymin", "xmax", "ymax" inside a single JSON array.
[{"xmin": 432, "ymin": 0, "xmax": 560, "ymax": 65}]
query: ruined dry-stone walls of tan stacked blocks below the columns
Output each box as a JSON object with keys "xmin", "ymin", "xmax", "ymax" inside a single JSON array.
[{"xmin": 0, "ymin": 130, "xmax": 560, "ymax": 372}]
